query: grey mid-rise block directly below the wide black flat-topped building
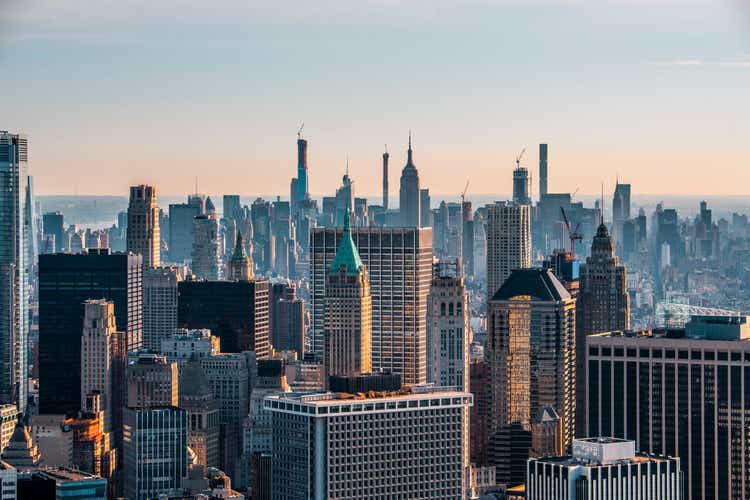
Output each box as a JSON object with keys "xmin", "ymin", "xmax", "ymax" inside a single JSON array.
[{"xmin": 200, "ymin": 353, "xmax": 255, "ymax": 476}]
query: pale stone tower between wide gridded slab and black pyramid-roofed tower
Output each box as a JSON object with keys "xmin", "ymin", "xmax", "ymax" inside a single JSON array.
[{"xmin": 427, "ymin": 260, "xmax": 469, "ymax": 391}]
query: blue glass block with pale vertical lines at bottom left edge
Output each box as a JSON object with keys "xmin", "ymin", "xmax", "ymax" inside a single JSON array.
[{"xmin": 123, "ymin": 406, "xmax": 188, "ymax": 500}]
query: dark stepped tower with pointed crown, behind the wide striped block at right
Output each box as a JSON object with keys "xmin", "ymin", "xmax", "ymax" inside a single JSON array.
[{"xmin": 576, "ymin": 223, "xmax": 630, "ymax": 436}]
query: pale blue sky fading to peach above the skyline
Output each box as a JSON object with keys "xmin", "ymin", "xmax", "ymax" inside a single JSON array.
[{"xmin": 0, "ymin": 0, "xmax": 750, "ymax": 199}]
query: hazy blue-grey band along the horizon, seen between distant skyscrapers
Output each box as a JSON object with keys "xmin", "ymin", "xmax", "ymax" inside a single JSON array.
[{"xmin": 37, "ymin": 193, "xmax": 750, "ymax": 228}]
